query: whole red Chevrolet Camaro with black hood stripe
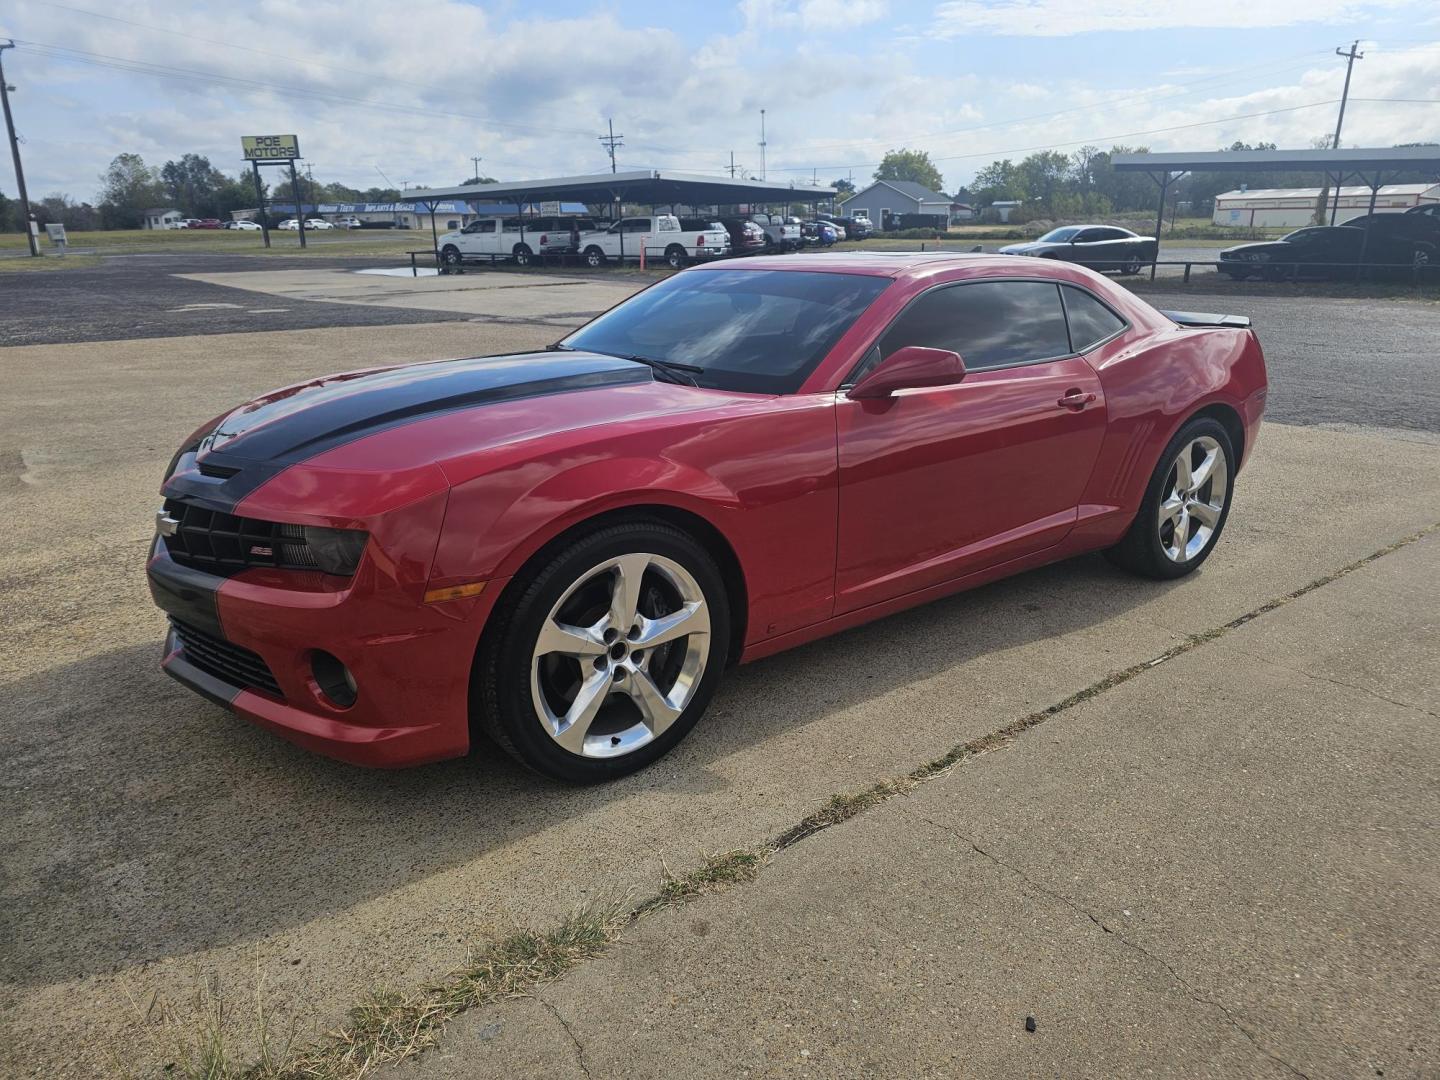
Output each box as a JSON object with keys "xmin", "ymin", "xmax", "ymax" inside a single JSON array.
[{"xmin": 148, "ymin": 253, "xmax": 1266, "ymax": 780}]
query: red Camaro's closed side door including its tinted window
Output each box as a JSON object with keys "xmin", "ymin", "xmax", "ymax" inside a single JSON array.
[{"xmin": 835, "ymin": 279, "xmax": 1106, "ymax": 613}]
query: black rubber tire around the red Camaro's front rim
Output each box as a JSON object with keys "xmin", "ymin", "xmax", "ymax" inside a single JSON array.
[{"xmin": 471, "ymin": 520, "xmax": 730, "ymax": 783}]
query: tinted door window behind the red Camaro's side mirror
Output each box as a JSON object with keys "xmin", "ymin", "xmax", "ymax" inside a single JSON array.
[{"xmin": 855, "ymin": 281, "xmax": 1070, "ymax": 377}]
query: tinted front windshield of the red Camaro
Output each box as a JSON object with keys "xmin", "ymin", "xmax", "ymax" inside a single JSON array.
[{"xmin": 563, "ymin": 269, "xmax": 890, "ymax": 393}]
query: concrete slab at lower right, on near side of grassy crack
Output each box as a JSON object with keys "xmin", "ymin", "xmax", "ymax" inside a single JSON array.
[{"xmin": 382, "ymin": 533, "xmax": 1440, "ymax": 1080}]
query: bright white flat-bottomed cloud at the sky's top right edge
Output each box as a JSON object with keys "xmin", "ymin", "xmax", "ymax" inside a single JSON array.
[{"xmin": 935, "ymin": 0, "xmax": 1404, "ymax": 37}]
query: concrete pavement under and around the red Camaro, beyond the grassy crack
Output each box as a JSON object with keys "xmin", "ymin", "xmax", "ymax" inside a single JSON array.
[{"xmin": 0, "ymin": 311, "xmax": 1440, "ymax": 1077}]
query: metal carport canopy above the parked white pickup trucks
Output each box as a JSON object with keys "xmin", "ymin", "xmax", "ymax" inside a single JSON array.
[{"xmin": 405, "ymin": 168, "xmax": 835, "ymax": 206}]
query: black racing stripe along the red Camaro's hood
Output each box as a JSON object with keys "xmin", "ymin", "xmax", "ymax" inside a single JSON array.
[{"xmin": 164, "ymin": 351, "xmax": 652, "ymax": 511}]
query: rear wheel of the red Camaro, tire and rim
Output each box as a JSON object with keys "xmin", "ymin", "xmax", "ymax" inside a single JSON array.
[{"xmin": 1106, "ymin": 416, "xmax": 1236, "ymax": 580}]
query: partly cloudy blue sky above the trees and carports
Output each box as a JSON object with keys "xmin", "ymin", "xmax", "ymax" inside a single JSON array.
[{"xmin": 0, "ymin": 0, "xmax": 1440, "ymax": 200}]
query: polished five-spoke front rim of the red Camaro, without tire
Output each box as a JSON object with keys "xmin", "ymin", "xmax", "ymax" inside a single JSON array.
[{"xmin": 530, "ymin": 553, "xmax": 710, "ymax": 757}]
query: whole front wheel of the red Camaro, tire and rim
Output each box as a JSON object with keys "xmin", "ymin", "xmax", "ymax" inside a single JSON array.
[{"xmin": 471, "ymin": 521, "xmax": 730, "ymax": 782}]
